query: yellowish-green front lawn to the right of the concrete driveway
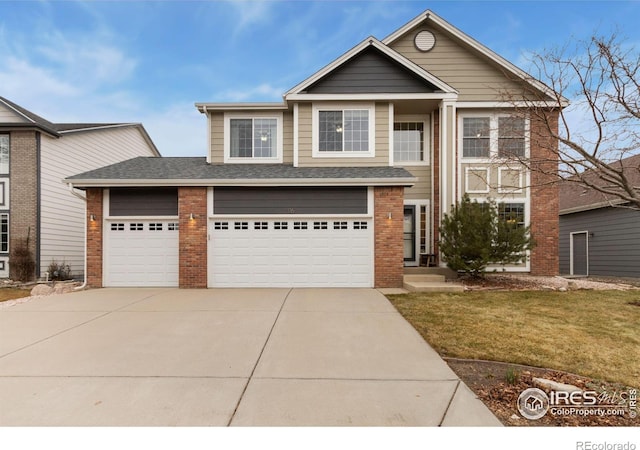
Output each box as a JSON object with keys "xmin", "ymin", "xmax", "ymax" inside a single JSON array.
[{"xmin": 389, "ymin": 290, "xmax": 640, "ymax": 387}]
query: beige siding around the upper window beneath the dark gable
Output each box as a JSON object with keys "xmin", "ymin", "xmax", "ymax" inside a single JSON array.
[{"xmin": 298, "ymin": 103, "xmax": 389, "ymax": 167}]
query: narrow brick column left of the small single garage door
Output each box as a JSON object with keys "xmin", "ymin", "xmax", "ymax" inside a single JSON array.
[{"xmin": 85, "ymin": 188, "xmax": 103, "ymax": 288}]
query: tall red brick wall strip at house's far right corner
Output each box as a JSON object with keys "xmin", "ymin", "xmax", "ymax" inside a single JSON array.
[{"xmin": 531, "ymin": 112, "xmax": 560, "ymax": 275}]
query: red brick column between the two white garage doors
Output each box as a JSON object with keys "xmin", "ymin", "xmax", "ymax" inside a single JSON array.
[{"xmin": 178, "ymin": 187, "xmax": 208, "ymax": 288}]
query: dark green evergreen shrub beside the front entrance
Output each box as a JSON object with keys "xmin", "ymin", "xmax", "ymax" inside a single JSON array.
[{"xmin": 440, "ymin": 194, "xmax": 535, "ymax": 277}]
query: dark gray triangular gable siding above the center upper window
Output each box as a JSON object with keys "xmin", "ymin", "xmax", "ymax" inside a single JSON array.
[{"xmin": 307, "ymin": 48, "xmax": 437, "ymax": 94}]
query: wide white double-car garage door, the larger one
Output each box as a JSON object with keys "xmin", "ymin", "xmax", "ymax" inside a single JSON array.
[{"xmin": 208, "ymin": 218, "xmax": 373, "ymax": 287}]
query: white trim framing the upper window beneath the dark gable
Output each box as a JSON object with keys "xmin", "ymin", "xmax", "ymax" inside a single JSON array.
[{"xmin": 311, "ymin": 103, "xmax": 376, "ymax": 158}]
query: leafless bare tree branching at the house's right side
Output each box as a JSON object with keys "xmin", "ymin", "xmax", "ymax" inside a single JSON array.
[{"xmin": 501, "ymin": 33, "xmax": 640, "ymax": 209}]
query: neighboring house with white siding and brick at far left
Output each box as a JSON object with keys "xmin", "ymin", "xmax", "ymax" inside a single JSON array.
[{"xmin": 0, "ymin": 97, "xmax": 160, "ymax": 278}]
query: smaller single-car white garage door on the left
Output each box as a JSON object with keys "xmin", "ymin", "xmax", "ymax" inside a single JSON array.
[{"xmin": 103, "ymin": 220, "xmax": 178, "ymax": 287}]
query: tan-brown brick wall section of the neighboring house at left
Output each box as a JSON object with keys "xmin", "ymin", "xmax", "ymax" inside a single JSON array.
[{"xmin": 9, "ymin": 131, "xmax": 40, "ymax": 278}]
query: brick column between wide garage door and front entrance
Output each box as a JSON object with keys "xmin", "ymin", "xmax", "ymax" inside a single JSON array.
[{"xmin": 373, "ymin": 186, "xmax": 404, "ymax": 287}]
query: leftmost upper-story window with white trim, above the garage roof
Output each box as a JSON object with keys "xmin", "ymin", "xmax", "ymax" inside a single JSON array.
[{"xmin": 224, "ymin": 113, "xmax": 282, "ymax": 163}]
